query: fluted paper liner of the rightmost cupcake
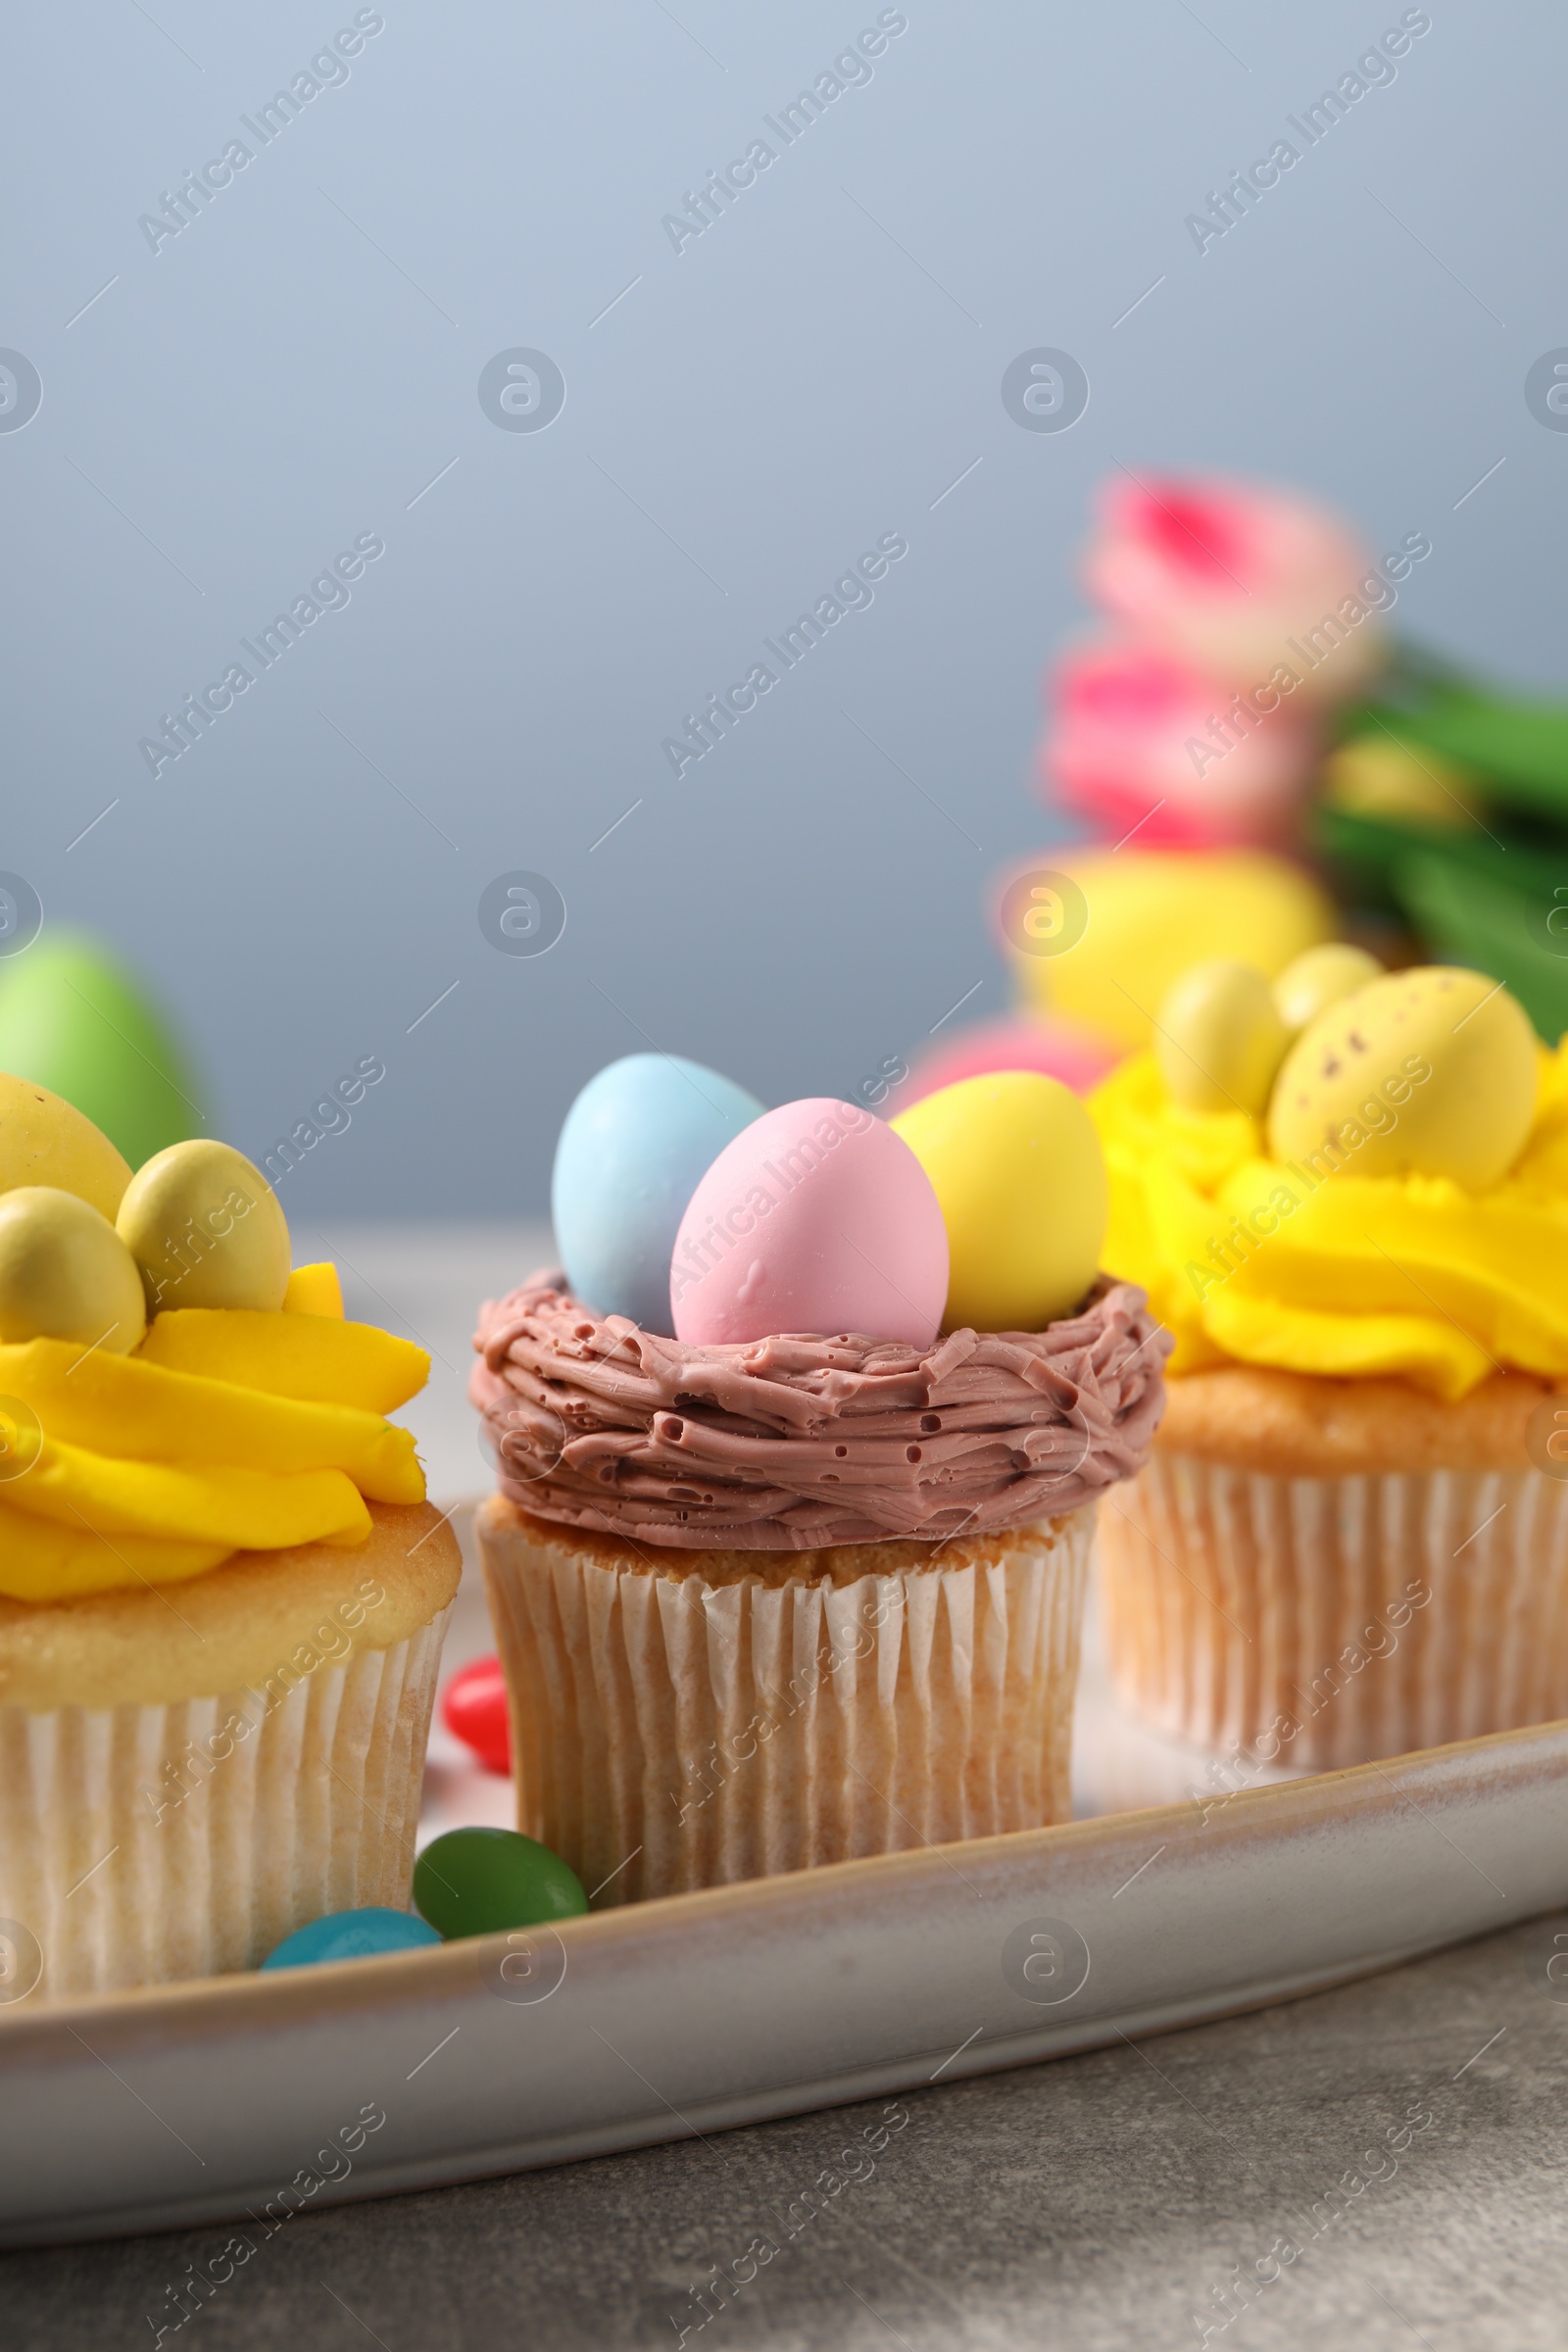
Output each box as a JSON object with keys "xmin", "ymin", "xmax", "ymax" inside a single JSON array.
[{"xmin": 1101, "ymin": 1451, "xmax": 1568, "ymax": 1771}]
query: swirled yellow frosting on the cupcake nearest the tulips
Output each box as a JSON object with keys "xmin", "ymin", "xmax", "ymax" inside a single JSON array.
[{"xmin": 1089, "ymin": 1040, "xmax": 1568, "ymax": 1399}]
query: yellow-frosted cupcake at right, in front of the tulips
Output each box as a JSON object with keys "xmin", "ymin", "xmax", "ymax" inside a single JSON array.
[{"xmin": 1091, "ymin": 948, "xmax": 1568, "ymax": 1769}]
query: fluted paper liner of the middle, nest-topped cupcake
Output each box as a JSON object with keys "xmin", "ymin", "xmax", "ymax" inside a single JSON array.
[{"xmin": 479, "ymin": 1500, "xmax": 1093, "ymax": 1905}]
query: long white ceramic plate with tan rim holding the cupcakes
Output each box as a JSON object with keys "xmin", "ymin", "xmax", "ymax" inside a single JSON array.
[{"xmin": 0, "ymin": 1495, "xmax": 1568, "ymax": 2246}]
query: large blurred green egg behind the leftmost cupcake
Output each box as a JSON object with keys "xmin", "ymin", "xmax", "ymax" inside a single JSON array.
[{"xmin": 0, "ymin": 927, "xmax": 202, "ymax": 1169}]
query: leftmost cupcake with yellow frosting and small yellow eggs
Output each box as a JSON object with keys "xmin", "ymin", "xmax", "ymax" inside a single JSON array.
[{"xmin": 0, "ymin": 1077, "xmax": 459, "ymax": 1994}]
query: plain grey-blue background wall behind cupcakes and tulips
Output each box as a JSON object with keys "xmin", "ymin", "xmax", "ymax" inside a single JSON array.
[{"xmin": 0, "ymin": 0, "xmax": 1568, "ymax": 1213}]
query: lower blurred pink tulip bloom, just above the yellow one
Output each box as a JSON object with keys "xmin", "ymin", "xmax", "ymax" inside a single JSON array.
[{"xmin": 1042, "ymin": 645, "xmax": 1321, "ymax": 849}]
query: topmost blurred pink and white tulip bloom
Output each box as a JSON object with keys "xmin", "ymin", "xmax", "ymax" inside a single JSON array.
[{"xmin": 1084, "ymin": 475, "xmax": 1408, "ymax": 701}]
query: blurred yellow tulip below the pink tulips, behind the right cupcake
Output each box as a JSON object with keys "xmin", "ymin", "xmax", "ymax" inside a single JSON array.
[{"xmin": 1004, "ymin": 845, "xmax": 1336, "ymax": 1052}]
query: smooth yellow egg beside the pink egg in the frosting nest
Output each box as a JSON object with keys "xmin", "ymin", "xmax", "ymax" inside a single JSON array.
[{"xmin": 891, "ymin": 1070, "xmax": 1109, "ymax": 1331}]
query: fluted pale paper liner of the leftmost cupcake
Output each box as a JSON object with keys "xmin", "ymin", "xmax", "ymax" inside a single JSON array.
[{"xmin": 0, "ymin": 1609, "xmax": 449, "ymax": 1997}]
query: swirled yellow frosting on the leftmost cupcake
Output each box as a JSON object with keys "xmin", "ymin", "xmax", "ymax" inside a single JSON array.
[{"xmin": 0, "ymin": 1268, "xmax": 430, "ymax": 1601}]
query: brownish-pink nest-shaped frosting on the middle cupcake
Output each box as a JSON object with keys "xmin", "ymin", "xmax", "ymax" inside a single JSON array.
[{"xmin": 467, "ymin": 1272, "xmax": 1173, "ymax": 1552}]
